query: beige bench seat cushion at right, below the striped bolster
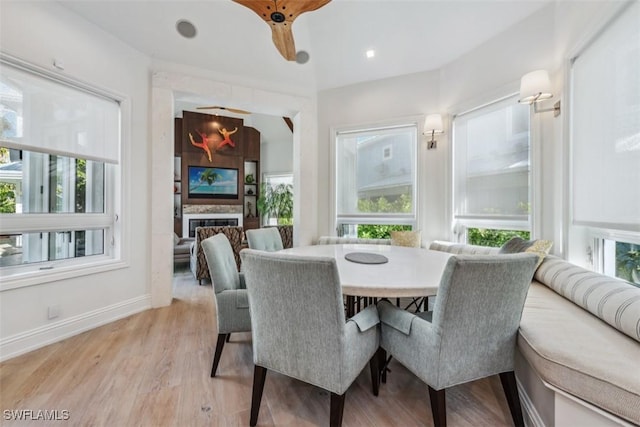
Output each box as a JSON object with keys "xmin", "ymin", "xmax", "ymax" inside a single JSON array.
[{"xmin": 518, "ymin": 280, "xmax": 640, "ymax": 424}]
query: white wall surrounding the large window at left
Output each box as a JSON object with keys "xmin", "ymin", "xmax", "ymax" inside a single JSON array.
[{"xmin": 0, "ymin": 2, "xmax": 151, "ymax": 359}]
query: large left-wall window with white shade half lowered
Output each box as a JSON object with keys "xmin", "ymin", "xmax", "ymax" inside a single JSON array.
[{"xmin": 0, "ymin": 56, "xmax": 120, "ymax": 286}]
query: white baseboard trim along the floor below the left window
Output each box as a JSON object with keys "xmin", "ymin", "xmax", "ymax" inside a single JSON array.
[{"xmin": 0, "ymin": 294, "xmax": 151, "ymax": 362}]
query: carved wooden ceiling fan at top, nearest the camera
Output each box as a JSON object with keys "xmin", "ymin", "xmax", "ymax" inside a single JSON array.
[{"xmin": 233, "ymin": 0, "xmax": 331, "ymax": 61}]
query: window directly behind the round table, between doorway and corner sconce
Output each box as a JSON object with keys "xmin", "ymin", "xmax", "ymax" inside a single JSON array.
[{"xmin": 335, "ymin": 122, "xmax": 418, "ymax": 237}]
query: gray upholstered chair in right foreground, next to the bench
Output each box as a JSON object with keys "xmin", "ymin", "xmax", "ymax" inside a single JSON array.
[{"xmin": 378, "ymin": 254, "xmax": 538, "ymax": 427}]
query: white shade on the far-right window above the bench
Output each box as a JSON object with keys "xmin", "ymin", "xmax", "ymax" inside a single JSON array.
[{"xmin": 571, "ymin": 2, "xmax": 640, "ymax": 231}]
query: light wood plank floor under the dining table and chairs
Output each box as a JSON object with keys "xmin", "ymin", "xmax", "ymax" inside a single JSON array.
[{"xmin": 0, "ymin": 269, "xmax": 511, "ymax": 427}]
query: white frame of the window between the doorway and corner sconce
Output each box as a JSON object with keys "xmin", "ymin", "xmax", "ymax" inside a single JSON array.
[{"xmin": 329, "ymin": 116, "xmax": 424, "ymax": 234}]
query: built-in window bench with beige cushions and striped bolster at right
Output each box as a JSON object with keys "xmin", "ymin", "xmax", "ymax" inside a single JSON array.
[{"xmin": 430, "ymin": 241, "xmax": 640, "ymax": 427}]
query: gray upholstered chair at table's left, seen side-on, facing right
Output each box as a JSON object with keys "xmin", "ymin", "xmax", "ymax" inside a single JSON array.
[{"xmin": 202, "ymin": 233, "xmax": 251, "ymax": 377}]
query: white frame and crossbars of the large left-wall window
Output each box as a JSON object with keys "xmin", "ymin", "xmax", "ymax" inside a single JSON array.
[{"xmin": 0, "ymin": 53, "xmax": 126, "ymax": 292}]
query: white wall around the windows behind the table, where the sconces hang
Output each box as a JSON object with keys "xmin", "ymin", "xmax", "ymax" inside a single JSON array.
[{"xmin": 318, "ymin": 1, "xmax": 620, "ymax": 254}]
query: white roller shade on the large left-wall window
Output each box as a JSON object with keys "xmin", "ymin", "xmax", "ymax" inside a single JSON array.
[{"xmin": 0, "ymin": 60, "xmax": 120, "ymax": 163}]
